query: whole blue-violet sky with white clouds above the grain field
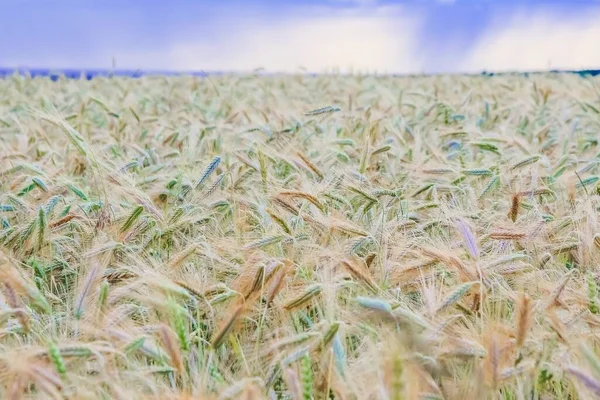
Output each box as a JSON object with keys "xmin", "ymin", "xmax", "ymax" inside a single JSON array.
[{"xmin": 0, "ymin": 0, "xmax": 600, "ymax": 74}]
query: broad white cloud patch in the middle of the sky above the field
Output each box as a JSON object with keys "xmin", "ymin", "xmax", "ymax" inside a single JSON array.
[{"xmin": 117, "ymin": 7, "xmax": 424, "ymax": 73}]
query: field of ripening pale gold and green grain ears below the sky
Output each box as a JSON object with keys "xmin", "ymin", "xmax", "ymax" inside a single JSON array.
[{"xmin": 0, "ymin": 74, "xmax": 600, "ymax": 400}]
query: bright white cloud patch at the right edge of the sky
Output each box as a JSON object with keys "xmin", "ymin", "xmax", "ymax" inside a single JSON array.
[{"xmin": 460, "ymin": 11, "xmax": 600, "ymax": 72}]
